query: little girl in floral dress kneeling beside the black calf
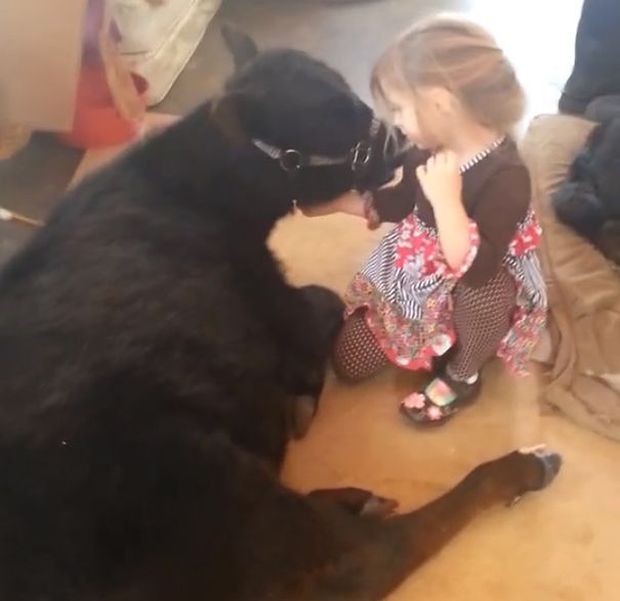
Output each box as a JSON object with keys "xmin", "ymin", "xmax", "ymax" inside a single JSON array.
[{"xmin": 302, "ymin": 17, "xmax": 546, "ymax": 424}]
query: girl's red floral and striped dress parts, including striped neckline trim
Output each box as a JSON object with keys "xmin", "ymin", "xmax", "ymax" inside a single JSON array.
[{"xmin": 345, "ymin": 142, "xmax": 547, "ymax": 374}]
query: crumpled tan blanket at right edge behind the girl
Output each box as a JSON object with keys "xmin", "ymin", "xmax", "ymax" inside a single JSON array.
[{"xmin": 521, "ymin": 115, "xmax": 620, "ymax": 440}]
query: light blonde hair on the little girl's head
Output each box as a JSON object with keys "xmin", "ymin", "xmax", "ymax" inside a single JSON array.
[{"xmin": 371, "ymin": 15, "xmax": 525, "ymax": 133}]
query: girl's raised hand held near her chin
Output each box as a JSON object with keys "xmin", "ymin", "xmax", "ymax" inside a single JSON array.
[{"xmin": 416, "ymin": 152, "xmax": 463, "ymax": 210}]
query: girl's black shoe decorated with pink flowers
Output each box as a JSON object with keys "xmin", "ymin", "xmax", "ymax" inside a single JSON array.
[{"xmin": 400, "ymin": 371, "xmax": 481, "ymax": 426}]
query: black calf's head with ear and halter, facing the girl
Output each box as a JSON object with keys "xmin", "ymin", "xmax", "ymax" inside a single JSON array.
[{"xmin": 214, "ymin": 28, "xmax": 404, "ymax": 216}]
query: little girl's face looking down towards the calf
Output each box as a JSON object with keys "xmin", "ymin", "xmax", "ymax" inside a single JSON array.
[{"xmin": 384, "ymin": 81, "xmax": 450, "ymax": 150}]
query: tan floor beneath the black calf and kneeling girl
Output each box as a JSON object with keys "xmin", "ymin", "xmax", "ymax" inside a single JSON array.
[{"xmin": 76, "ymin": 120, "xmax": 620, "ymax": 601}]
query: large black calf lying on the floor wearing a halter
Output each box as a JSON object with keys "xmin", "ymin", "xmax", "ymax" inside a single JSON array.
[{"xmin": 0, "ymin": 25, "xmax": 558, "ymax": 601}]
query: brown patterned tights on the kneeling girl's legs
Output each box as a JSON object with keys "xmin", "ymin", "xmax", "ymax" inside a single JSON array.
[{"xmin": 334, "ymin": 269, "xmax": 516, "ymax": 381}]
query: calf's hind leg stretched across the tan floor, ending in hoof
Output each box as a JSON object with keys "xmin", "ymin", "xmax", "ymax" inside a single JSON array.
[{"xmin": 304, "ymin": 449, "xmax": 561, "ymax": 601}]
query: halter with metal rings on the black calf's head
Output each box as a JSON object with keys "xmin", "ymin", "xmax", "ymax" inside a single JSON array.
[{"xmin": 252, "ymin": 117, "xmax": 381, "ymax": 174}]
